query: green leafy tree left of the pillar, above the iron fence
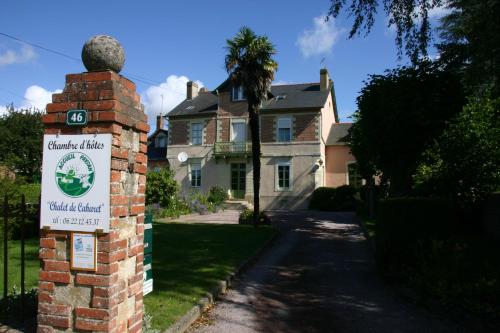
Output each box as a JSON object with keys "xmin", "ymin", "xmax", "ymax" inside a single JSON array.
[{"xmin": 0, "ymin": 106, "xmax": 43, "ymax": 182}]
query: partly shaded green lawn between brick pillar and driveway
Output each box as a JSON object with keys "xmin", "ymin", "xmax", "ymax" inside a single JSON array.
[{"xmin": 144, "ymin": 223, "xmax": 276, "ymax": 329}]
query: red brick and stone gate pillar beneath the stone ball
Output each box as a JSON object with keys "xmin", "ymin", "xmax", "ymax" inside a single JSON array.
[{"xmin": 38, "ymin": 71, "xmax": 149, "ymax": 333}]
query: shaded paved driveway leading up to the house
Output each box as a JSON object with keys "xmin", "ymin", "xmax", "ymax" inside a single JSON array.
[{"xmin": 191, "ymin": 211, "xmax": 464, "ymax": 333}]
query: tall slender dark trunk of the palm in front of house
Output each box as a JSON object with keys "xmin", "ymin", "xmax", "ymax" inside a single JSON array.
[{"xmin": 248, "ymin": 105, "xmax": 260, "ymax": 227}]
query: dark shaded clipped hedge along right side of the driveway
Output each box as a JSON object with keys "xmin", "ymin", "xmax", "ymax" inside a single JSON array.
[{"xmin": 375, "ymin": 198, "xmax": 500, "ymax": 322}]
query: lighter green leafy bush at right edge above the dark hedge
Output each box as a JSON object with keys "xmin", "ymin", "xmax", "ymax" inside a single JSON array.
[{"xmin": 414, "ymin": 94, "xmax": 500, "ymax": 208}]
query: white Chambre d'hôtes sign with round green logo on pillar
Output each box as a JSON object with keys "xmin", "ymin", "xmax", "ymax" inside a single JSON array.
[{"xmin": 40, "ymin": 134, "xmax": 111, "ymax": 232}]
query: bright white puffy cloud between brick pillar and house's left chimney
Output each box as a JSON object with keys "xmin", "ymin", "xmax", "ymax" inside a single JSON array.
[{"xmin": 141, "ymin": 75, "xmax": 203, "ymax": 122}]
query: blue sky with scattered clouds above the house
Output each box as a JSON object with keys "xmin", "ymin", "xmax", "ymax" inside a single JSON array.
[{"xmin": 0, "ymin": 0, "xmax": 446, "ymax": 130}]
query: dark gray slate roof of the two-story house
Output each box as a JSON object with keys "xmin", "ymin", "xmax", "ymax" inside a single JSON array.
[{"xmin": 167, "ymin": 80, "xmax": 330, "ymax": 117}]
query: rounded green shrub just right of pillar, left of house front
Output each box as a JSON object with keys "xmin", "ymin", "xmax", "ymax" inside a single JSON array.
[{"xmin": 146, "ymin": 168, "xmax": 179, "ymax": 208}]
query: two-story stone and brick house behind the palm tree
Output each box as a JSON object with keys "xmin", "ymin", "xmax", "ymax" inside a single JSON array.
[{"xmin": 167, "ymin": 69, "xmax": 344, "ymax": 209}]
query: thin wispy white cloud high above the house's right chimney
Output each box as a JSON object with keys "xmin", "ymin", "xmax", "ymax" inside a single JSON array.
[{"xmin": 296, "ymin": 16, "xmax": 344, "ymax": 58}]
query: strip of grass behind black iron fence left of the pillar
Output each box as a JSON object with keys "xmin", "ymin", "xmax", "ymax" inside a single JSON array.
[{"xmin": 0, "ymin": 238, "xmax": 40, "ymax": 298}]
